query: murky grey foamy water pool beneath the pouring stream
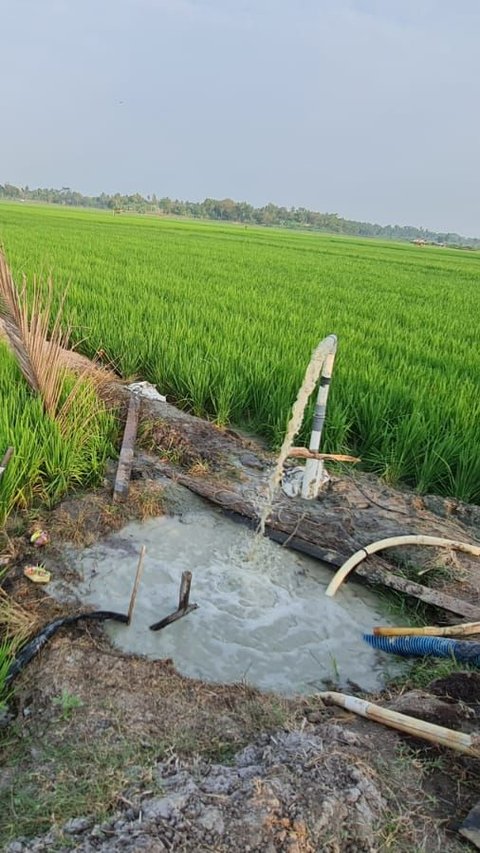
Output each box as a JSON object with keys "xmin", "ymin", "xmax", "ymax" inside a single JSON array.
[{"xmin": 57, "ymin": 499, "xmax": 400, "ymax": 694}]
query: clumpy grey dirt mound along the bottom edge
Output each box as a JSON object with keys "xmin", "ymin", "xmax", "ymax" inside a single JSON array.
[{"xmin": 1, "ymin": 723, "xmax": 420, "ymax": 853}]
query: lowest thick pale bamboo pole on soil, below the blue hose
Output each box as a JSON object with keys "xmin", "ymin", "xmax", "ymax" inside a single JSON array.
[{"xmin": 319, "ymin": 691, "xmax": 480, "ymax": 758}]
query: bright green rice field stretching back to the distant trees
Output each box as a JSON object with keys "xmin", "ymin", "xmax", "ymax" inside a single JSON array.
[{"xmin": 0, "ymin": 204, "xmax": 480, "ymax": 502}]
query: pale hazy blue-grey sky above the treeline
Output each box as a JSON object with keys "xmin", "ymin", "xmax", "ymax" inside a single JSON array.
[{"xmin": 0, "ymin": 0, "xmax": 480, "ymax": 236}]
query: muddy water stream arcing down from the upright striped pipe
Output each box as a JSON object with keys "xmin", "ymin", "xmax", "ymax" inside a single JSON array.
[{"xmin": 257, "ymin": 335, "xmax": 337, "ymax": 538}]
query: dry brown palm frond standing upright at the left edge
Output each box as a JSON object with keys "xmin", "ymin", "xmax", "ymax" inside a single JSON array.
[{"xmin": 0, "ymin": 252, "xmax": 108, "ymax": 429}]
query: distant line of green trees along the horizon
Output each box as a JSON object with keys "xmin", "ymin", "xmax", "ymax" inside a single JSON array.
[{"xmin": 0, "ymin": 183, "xmax": 480, "ymax": 248}]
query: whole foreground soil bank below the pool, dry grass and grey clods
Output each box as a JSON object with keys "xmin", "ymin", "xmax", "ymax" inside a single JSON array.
[{"xmin": 0, "ymin": 631, "xmax": 480, "ymax": 853}]
